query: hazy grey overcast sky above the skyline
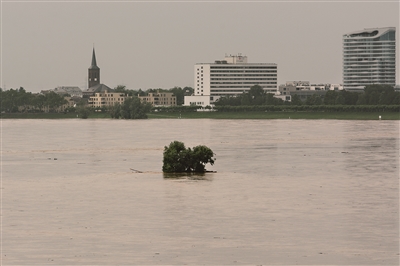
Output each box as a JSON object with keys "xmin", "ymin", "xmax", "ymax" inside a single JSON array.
[{"xmin": 0, "ymin": 1, "xmax": 400, "ymax": 92}]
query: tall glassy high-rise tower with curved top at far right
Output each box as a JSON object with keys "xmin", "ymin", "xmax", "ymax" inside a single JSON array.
[{"xmin": 343, "ymin": 27, "xmax": 396, "ymax": 91}]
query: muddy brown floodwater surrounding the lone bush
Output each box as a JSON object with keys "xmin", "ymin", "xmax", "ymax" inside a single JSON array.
[{"xmin": 1, "ymin": 119, "xmax": 399, "ymax": 265}]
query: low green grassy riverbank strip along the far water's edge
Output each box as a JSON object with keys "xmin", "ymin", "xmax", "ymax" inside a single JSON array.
[{"xmin": 0, "ymin": 112, "xmax": 400, "ymax": 120}]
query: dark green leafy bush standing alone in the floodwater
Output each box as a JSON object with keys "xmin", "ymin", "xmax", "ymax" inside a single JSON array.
[{"xmin": 162, "ymin": 141, "xmax": 216, "ymax": 173}]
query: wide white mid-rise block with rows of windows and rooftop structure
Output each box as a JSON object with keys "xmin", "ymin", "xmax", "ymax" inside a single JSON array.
[{"xmin": 194, "ymin": 54, "xmax": 278, "ymax": 102}]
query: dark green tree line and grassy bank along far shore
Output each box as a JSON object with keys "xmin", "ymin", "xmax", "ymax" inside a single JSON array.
[{"xmin": 0, "ymin": 85, "xmax": 400, "ymax": 120}]
